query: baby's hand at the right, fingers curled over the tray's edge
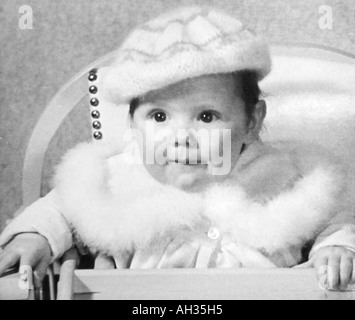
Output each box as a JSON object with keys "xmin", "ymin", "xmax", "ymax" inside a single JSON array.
[{"xmin": 311, "ymin": 247, "xmax": 355, "ymax": 290}]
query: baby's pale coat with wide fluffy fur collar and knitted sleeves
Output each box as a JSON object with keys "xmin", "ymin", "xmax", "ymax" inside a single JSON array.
[{"xmin": 1, "ymin": 142, "xmax": 355, "ymax": 268}]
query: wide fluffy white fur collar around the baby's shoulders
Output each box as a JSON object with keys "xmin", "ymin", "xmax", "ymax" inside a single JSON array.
[{"xmin": 54, "ymin": 143, "xmax": 344, "ymax": 255}]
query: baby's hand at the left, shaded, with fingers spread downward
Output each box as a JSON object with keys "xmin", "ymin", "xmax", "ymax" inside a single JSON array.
[{"xmin": 0, "ymin": 233, "xmax": 51, "ymax": 288}]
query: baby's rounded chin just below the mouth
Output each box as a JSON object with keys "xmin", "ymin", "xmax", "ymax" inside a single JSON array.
[{"xmin": 165, "ymin": 163, "xmax": 210, "ymax": 192}]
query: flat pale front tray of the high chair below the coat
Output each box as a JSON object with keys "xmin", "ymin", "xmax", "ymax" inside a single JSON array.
[{"xmin": 61, "ymin": 269, "xmax": 355, "ymax": 300}]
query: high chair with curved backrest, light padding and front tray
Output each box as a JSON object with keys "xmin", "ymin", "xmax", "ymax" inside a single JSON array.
[{"xmin": 0, "ymin": 43, "xmax": 355, "ymax": 300}]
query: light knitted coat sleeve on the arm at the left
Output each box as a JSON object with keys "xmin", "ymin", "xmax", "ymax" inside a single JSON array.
[{"xmin": 0, "ymin": 189, "xmax": 73, "ymax": 260}]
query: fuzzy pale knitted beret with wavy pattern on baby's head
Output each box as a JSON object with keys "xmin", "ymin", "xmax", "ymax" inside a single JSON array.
[{"xmin": 101, "ymin": 7, "xmax": 271, "ymax": 103}]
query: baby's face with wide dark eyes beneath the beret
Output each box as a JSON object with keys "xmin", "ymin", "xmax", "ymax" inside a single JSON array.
[{"xmin": 132, "ymin": 75, "xmax": 264, "ymax": 192}]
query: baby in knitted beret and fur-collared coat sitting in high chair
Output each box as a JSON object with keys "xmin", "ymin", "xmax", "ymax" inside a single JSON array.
[{"xmin": 0, "ymin": 7, "xmax": 355, "ymax": 289}]
